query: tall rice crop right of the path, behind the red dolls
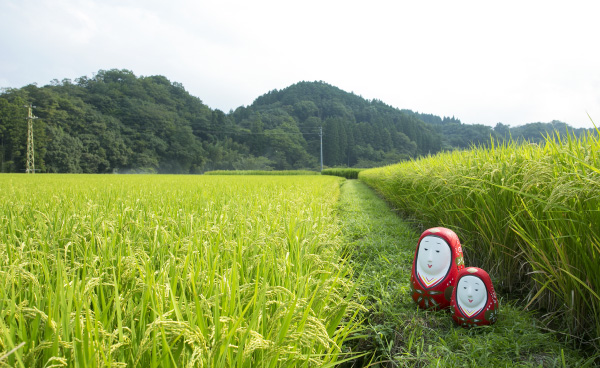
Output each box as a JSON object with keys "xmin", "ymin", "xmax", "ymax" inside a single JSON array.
[{"xmin": 359, "ymin": 134, "xmax": 600, "ymax": 349}]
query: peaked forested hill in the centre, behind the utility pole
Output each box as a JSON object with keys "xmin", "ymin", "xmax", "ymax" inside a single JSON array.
[{"xmin": 232, "ymin": 82, "xmax": 442, "ymax": 167}]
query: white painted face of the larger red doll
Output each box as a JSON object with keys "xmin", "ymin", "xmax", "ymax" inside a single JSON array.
[{"xmin": 417, "ymin": 236, "xmax": 452, "ymax": 277}]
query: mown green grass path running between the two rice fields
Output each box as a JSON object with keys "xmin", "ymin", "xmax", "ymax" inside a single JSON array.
[{"xmin": 339, "ymin": 180, "xmax": 594, "ymax": 367}]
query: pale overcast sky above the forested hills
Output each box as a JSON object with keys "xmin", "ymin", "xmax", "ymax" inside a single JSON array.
[{"xmin": 0, "ymin": 0, "xmax": 600, "ymax": 127}]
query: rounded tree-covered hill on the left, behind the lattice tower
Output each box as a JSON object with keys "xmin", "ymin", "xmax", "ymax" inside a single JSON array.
[{"xmin": 0, "ymin": 70, "xmax": 232, "ymax": 173}]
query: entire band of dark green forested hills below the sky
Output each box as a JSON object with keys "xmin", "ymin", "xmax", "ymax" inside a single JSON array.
[{"xmin": 0, "ymin": 69, "xmax": 596, "ymax": 173}]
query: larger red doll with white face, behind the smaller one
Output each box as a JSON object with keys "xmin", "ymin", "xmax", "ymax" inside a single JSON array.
[{"xmin": 411, "ymin": 227, "xmax": 465, "ymax": 309}]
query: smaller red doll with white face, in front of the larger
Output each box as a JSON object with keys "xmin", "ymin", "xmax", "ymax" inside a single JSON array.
[{"xmin": 452, "ymin": 267, "xmax": 498, "ymax": 327}]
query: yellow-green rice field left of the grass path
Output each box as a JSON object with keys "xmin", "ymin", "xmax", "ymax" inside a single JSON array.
[{"xmin": 0, "ymin": 175, "xmax": 359, "ymax": 367}]
